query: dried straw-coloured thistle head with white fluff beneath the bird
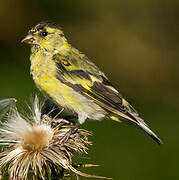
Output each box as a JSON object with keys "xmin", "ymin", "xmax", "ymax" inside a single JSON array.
[{"xmin": 0, "ymin": 98, "xmax": 111, "ymax": 180}]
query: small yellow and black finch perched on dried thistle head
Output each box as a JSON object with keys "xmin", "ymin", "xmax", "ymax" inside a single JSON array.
[{"xmin": 21, "ymin": 21, "xmax": 162, "ymax": 144}]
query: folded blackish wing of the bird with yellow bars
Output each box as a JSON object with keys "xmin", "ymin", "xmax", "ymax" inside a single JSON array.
[{"xmin": 56, "ymin": 54, "xmax": 136, "ymax": 121}]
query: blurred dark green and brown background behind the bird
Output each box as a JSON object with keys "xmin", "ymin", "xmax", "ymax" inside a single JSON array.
[{"xmin": 0, "ymin": 0, "xmax": 179, "ymax": 180}]
